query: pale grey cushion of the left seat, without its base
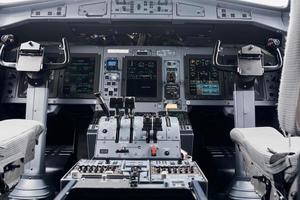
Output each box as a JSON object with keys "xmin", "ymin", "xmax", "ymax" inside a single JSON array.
[{"xmin": 0, "ymin": 119, "xmax": 44, "ymax": 172}]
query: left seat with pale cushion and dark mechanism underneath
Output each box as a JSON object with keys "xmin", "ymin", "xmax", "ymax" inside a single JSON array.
[{"xmin": 0, "ymin": 119, "xmax": 44, "ymax": 193}]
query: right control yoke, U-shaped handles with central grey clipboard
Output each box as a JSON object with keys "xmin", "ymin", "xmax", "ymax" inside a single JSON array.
[{"xmin": 213, "ymin": 38, "xmax": 283, "ymax": 76}]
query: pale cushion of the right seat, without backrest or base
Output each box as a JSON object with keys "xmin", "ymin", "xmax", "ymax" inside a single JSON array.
[{"xmin": 230, "ymin": 127, "xmax": 300, "ymax": 179}]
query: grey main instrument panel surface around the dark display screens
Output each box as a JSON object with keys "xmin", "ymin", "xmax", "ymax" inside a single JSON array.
[{"xmin": 2, "ymin": 46, "xmax": 280, "ymax": 108}]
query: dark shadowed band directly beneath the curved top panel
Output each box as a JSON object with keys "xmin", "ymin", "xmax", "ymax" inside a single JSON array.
[{"xmin": 0, "ymin": 22, "xmax": 282, "ymax": 46}]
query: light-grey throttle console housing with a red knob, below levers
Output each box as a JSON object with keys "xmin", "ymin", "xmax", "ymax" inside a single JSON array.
[{"xmin": 94, "ymin": 117, "xmax": 181, "ymax": 159}]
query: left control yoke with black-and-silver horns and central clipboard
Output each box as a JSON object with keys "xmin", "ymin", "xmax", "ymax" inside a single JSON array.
[{"xmin": 0, "ymin": 34, "xmax": 70, "ymax": 72}]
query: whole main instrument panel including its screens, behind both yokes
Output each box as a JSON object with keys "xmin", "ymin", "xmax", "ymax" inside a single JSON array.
[{"xmin": 2, "ymin": 46, "xmax": 280, "ymax": 112}]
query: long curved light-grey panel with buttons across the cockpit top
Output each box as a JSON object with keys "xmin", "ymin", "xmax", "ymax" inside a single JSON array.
[{"xmin": 0, "ymin": 0, "xmax": 287, "ymax": 31}]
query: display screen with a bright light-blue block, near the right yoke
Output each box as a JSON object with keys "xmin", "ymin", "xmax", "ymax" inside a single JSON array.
[{"xmin": 186, "ymin": 56, "xmax": 222, "ymax": 99}]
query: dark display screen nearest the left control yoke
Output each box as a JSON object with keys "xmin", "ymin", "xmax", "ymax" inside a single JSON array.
[{"xmin": 63, "ymin": 57, "xmax": 96, "ymax": 97}]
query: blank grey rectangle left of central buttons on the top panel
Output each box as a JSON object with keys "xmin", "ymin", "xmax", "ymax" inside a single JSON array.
[{"xmin": 78, "ymin": 1, "xmax": 107, "ymax": 17}]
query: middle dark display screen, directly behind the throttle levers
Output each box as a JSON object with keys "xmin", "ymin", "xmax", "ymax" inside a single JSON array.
[{"xmin": 124, "ymin": 57, "xmax": 161, "ymax": 101}]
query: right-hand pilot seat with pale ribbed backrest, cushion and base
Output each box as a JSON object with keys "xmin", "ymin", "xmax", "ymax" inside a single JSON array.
[{"xmin": 230, "ymin": 0, "xmax": 300, "ymax": 199}]
